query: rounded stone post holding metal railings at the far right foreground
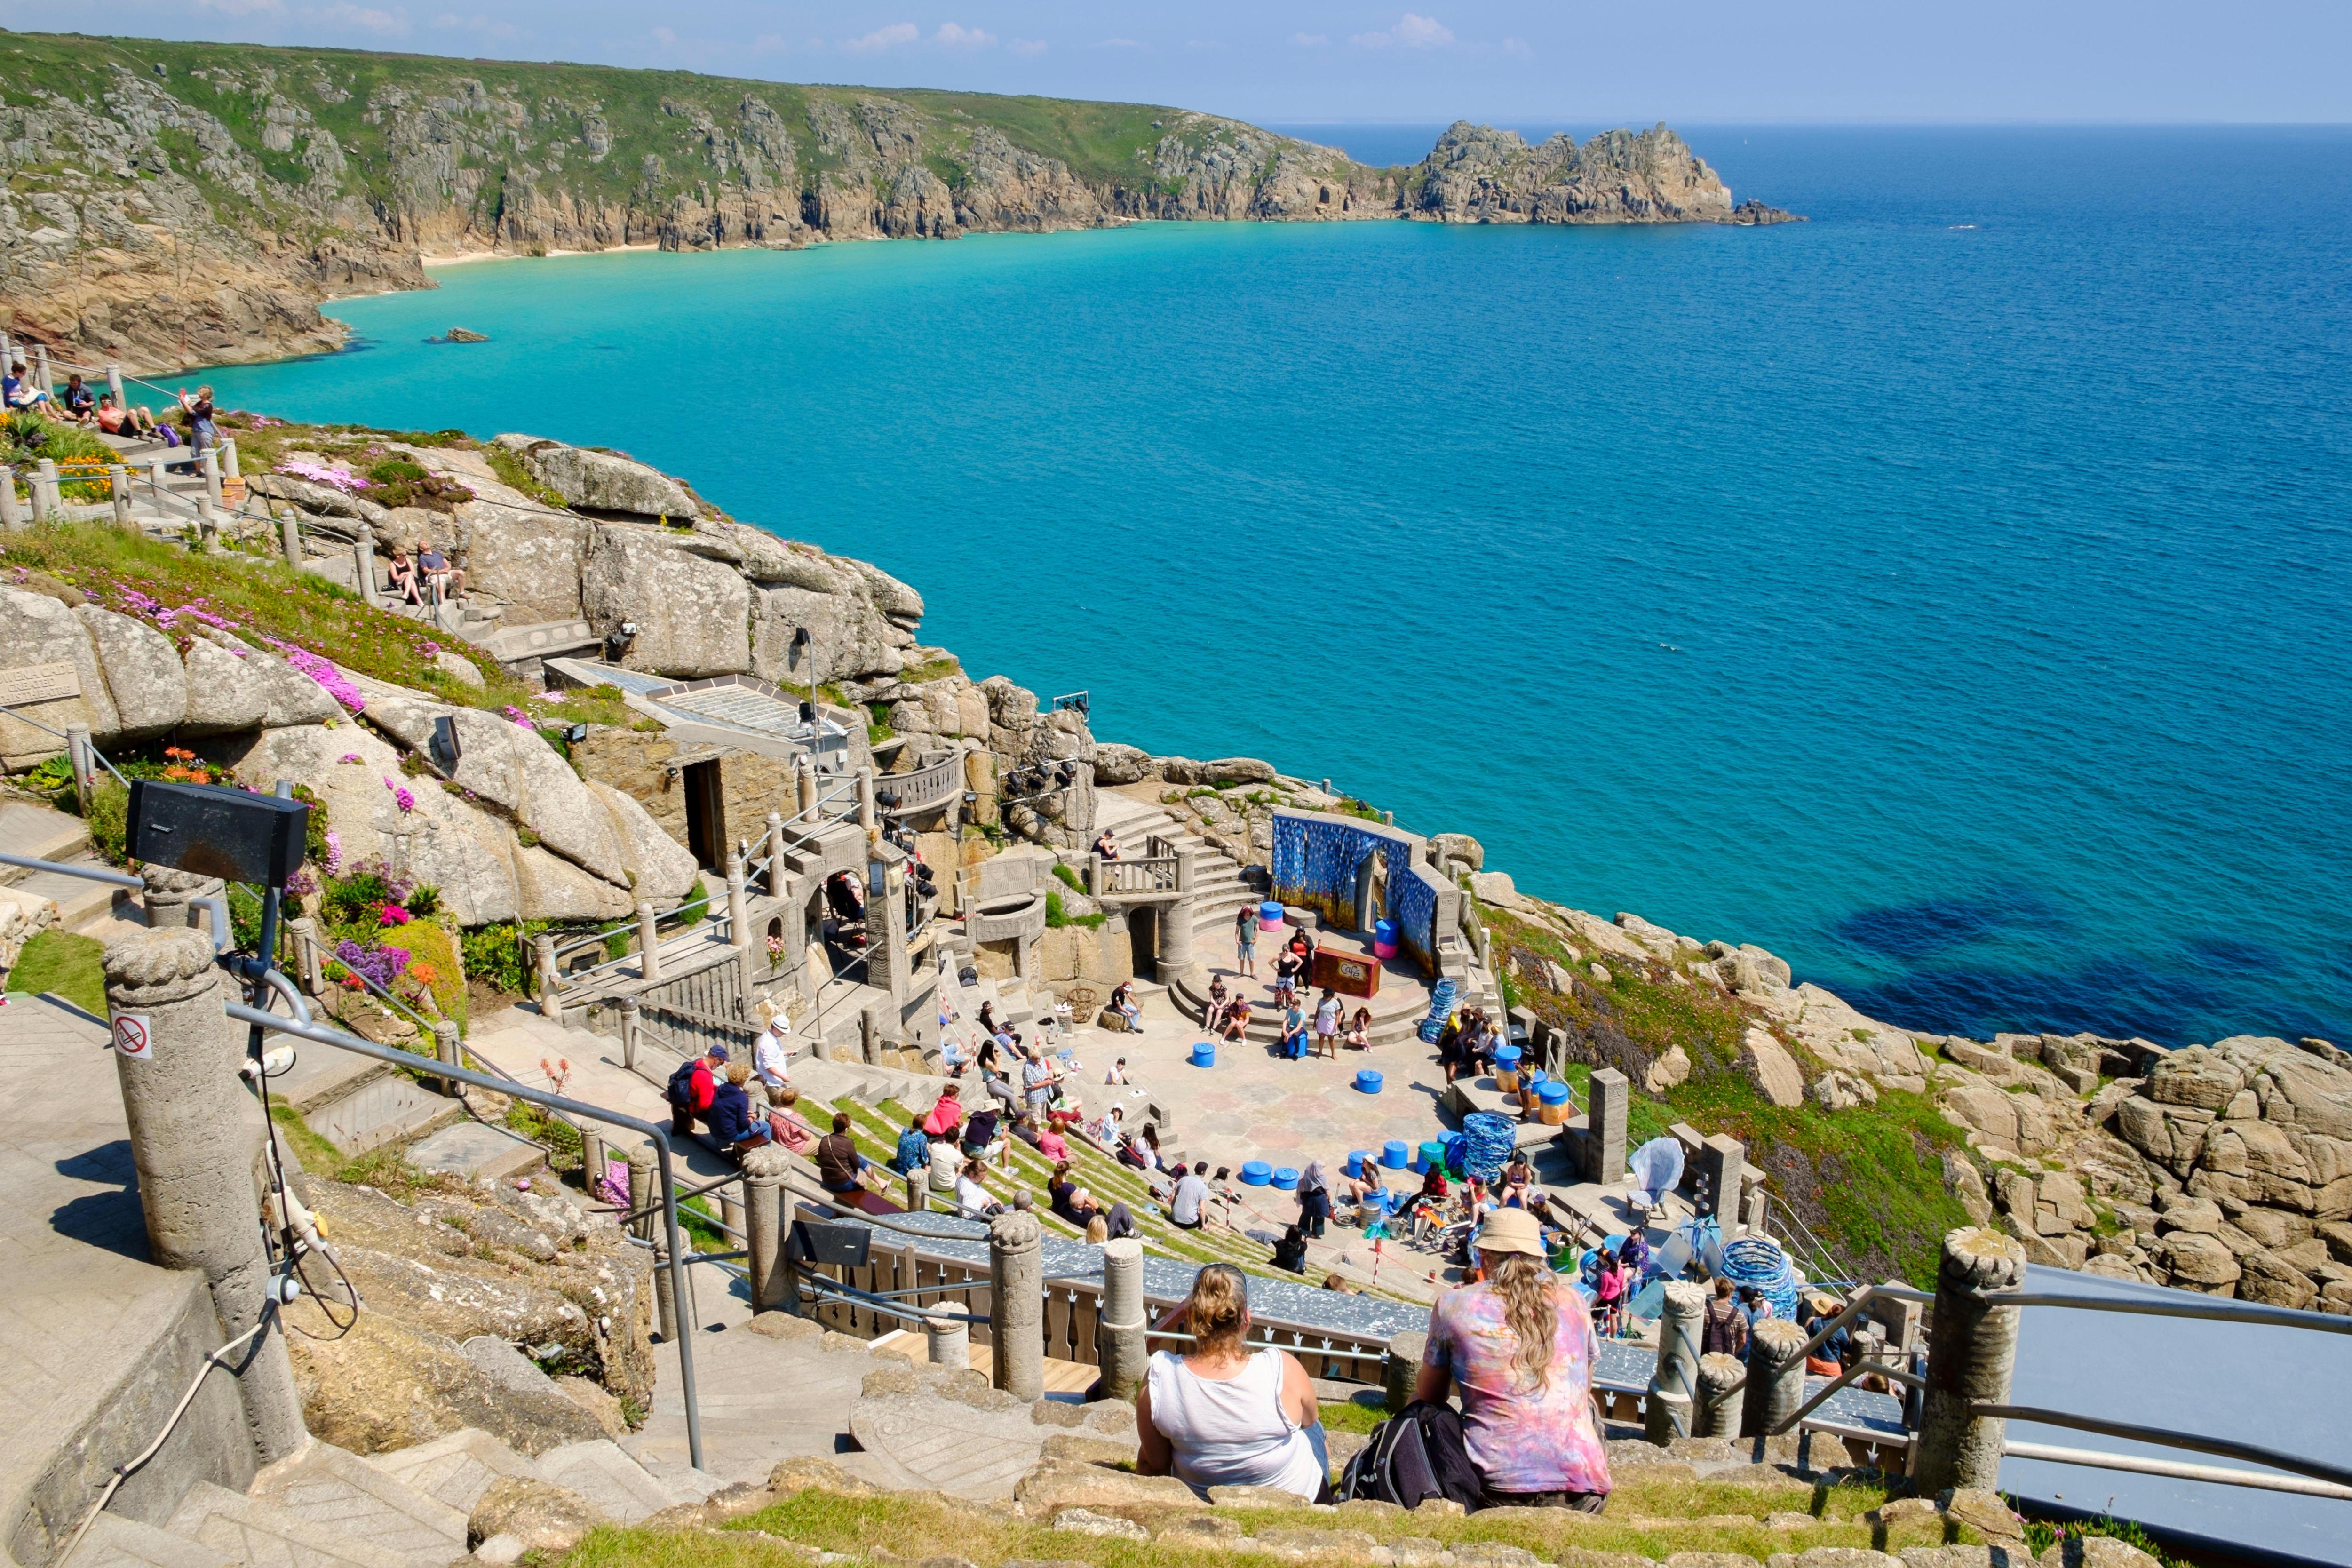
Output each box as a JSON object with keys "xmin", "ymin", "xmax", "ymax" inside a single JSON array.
[{"xmin": 1912, "ymin": 1227, "xmax": 2025, "ymax": 1497}]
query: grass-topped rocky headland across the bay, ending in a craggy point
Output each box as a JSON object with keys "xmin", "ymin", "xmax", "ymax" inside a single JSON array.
[{"xmin": 0, "ymin": 33, "xmax": 1785, "ymax": 372}]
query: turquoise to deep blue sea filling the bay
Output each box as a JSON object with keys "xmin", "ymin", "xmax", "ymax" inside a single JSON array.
[{"xmin": 214, "ymin": 129, "xmax": 2352, "ymax": 1042}]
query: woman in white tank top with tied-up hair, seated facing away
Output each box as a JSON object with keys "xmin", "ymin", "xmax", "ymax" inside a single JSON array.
[{"xmin": 1136, "ymin": 1262, "xmax": 1331, "ymax": 1500}]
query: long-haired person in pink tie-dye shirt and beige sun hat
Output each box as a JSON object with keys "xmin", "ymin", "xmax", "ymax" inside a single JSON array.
[{"xmin": 1414, "ymin": 1208, "xmax": 1609, "ymax": 1514}]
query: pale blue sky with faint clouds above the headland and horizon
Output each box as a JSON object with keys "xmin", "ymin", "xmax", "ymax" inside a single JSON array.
[{"xmin": 0, "ymin": 0, "xmax": 2352, "ymax": 125}]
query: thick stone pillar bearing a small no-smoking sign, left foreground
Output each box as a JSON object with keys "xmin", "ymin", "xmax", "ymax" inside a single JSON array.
[{"xmin": 106, "ymin": 929, "xmax": 310, "ymax": 1465}]
